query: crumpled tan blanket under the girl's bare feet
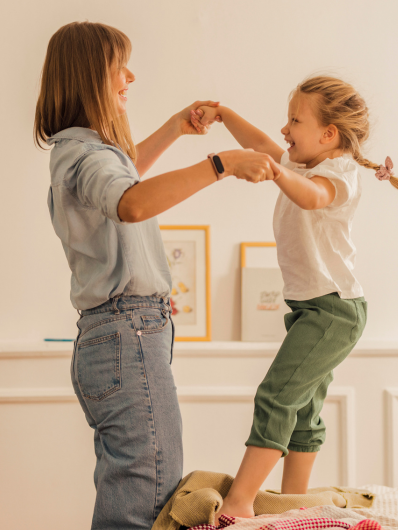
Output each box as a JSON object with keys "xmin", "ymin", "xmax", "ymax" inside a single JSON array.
[{"xmin": 152, "ymin": 471, "xmax": 374, "ymax": 530}]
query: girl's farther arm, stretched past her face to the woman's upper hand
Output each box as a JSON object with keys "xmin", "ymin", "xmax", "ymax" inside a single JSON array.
[{"xmin": 191, "ymin": 106, "xmax": 284, "ymax": 162}]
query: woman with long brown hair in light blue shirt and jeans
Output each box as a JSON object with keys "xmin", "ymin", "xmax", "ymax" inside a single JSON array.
[{"xmin": 35, "ymin": 22, "xmax": 272, "ymax": 530}]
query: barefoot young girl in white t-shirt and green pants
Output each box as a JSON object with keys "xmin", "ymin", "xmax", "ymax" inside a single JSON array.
[{"xmin": 191, "ymin": 76, "xmax": 398, "ymax": 517}]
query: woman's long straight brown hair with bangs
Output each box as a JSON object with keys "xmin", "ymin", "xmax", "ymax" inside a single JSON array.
[{"xmin": 34, "ymin": 22, "xmax": 137, "ymax": 162}]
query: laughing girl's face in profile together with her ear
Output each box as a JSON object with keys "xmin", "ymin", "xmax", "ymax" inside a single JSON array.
[{"xmin": 281, "ymin": 93, "xmax": 341, "ymax": 167}]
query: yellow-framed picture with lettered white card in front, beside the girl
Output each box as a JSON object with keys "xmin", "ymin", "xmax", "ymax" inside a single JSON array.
[{"xmin": 241, "ymin": 242, "xmax": 289, "ymax": 342}]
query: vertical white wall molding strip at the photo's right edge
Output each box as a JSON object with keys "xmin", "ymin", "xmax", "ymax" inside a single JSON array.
[{"xmin": 385, "ymin": 387, "xmax": 398, "ymax": 488}]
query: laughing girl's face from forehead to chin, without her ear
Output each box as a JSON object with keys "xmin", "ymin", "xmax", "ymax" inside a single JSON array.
[{"xmin": 281, "ymin": 94, "xmax": 326, "ymax": 164}]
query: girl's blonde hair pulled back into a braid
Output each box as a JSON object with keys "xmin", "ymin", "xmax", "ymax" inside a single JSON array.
[{"xmin": 291, "ymin": 76, "xmax": 398, "ymax": 189}]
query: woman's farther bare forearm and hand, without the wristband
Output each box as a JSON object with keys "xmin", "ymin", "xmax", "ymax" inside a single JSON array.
[{"xmin": 135, "ymin": 101, "xmax": 218, "ymax": 175}]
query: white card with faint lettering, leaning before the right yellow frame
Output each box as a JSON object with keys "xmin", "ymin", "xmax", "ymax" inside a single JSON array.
[{"xmin": 241, "ymin": 267, "xmax": 291, "ymax": 342}]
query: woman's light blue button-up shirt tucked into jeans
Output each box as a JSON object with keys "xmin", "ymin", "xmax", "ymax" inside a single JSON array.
[{"xmin": 47, "ymin": 127, "xmax": 171, "ymax": 310}]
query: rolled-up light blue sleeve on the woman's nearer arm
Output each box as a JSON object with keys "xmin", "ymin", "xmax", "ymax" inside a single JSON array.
[{"xmin": 76, "ymin": 149, "xmax": 139, "ymax": 224}]
